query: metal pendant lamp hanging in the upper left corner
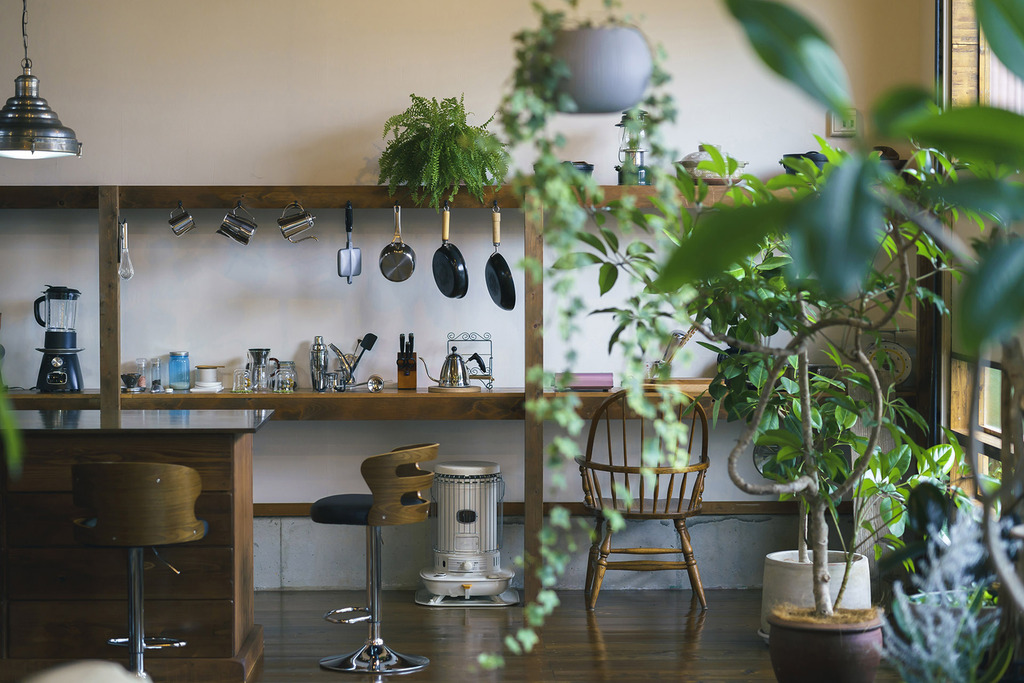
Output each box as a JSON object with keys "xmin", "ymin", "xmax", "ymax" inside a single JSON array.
[{"xmin": 0, "ymin": 0, "xmax": 82, "ymax": 159}]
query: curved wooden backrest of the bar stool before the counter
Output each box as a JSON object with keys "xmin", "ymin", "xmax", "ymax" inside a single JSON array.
[{"xmin": 72, "ymin": 463, "xmax": 206, "ymax": 547}]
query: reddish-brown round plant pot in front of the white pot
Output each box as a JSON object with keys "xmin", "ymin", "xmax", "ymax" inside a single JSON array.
[{"xmin": 768, "ymin": 613, "xmax": 882, "ymax": 683}]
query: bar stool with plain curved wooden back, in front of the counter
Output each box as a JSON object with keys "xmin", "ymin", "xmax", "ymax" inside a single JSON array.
[{"xmin": 72, "ymin": 463, "xmax": 206, "ymax": 680}]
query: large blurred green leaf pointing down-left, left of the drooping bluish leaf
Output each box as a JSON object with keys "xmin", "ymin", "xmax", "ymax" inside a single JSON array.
[{"xmin": 654, "ymin": 202, "xmax": 793, "ymax": 291}]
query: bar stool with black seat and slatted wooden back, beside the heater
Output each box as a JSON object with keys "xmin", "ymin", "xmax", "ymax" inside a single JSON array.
[{"xmin": 309, "ymin": 443, "xmax": 437, "ymax": 674}]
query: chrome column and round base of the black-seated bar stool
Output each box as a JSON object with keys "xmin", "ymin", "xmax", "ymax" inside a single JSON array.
[{"xmin": 319, "ymin": 526, "xmax": 430, "ymax": 674}]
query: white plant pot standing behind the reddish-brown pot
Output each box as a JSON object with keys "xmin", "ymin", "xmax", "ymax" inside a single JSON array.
[{"xmin": 758, "ymin": 550, "xmax": 871, "ymax": 639}]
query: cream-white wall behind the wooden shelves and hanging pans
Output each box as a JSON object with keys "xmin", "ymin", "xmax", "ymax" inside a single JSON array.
[{"xmin": 0, "ymin": 0, "xmax": 932, "ymax": 502}]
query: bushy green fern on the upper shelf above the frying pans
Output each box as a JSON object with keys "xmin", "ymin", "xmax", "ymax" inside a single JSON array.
[{"xmin": 378, "ymin": 94, "xmax": 509, "ymax": 209}]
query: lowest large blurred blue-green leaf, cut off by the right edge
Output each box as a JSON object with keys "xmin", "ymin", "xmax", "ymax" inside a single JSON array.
[{"xmin": 959, "ymin": 239, "xmax": 1024, "ymax": 353}]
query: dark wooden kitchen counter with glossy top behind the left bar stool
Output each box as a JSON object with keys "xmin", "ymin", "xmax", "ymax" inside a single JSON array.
[{"xmin": 0, "ymin": 410, "xmax": 270, "ymax": 682}]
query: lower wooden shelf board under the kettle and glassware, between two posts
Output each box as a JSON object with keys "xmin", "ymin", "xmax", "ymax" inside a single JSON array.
[{"xmin": 121, "ymin": 388, "xmax": 526, "ymax": 420}]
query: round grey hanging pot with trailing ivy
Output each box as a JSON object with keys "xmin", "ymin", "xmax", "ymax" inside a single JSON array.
[{"xmin": 552, "ymin": 26, "xmax": 653, "ymax": 114}]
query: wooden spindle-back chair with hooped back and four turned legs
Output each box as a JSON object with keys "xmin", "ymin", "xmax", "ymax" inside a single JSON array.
[{"xmin": 575, "ymin": 391, "xmax": 709, "ymax": 609}]
